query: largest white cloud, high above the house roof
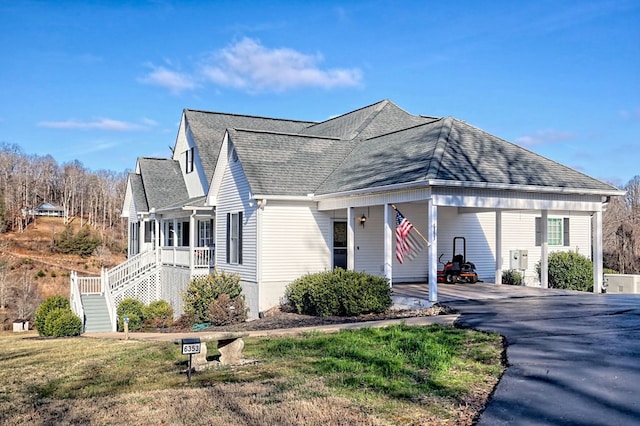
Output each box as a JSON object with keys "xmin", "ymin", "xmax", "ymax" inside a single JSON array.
[{"xmin": 201, "ymin": 38, "xmax": 362, "ymax": 92}]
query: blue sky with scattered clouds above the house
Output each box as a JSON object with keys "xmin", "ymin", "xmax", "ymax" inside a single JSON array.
[{"xmin": 0, "ymin": 0, "xmax": 640, "ymax": 185}]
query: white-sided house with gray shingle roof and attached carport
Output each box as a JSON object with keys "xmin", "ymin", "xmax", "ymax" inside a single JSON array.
[{"xmin": 72, "ymin": 100, "xmax": 622, "ymax": 332}]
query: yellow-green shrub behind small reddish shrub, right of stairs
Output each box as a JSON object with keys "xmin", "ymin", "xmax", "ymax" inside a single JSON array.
[{"xmin": 182, "ymin": 269, "xmax": 246, "ymax": 323}]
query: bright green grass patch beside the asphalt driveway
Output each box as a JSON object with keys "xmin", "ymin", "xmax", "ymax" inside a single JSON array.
[{"xmin": 249, "ymin": 325, "xmax": 502, "ymax": 400}]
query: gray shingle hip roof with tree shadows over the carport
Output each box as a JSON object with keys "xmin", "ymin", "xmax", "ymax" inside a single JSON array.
[{"xmin": 316, "ymin": 117, "xmax": 616, "ymax": 194}]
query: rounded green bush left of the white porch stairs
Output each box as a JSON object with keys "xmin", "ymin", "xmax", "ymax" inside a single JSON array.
[{"xmin": 34, "ymin": 296, "xmax": 82, "ymax": 337}]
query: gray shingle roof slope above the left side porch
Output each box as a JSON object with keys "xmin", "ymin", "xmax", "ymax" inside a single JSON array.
[{"xmin": 138, "ymin": 158, "xmax": 189, "ymax": 210}]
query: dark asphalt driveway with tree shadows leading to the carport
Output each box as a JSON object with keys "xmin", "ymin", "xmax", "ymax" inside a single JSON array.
[{"xmin": 394, "ymin": 283, "xmax": 640, "ymax": 425}]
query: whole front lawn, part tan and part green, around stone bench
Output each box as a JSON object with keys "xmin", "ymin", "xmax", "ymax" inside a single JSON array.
[{"xmin": 0, "ymin": 324, "xmax": 503, "ymax": 424}]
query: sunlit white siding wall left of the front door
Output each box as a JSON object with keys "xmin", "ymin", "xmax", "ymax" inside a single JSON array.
[{"xmin": 260, "ymin": 200, "xmax": 332, "ymax": 310}]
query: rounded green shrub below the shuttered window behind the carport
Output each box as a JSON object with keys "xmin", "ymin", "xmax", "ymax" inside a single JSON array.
[{"xmin": 536, "ymin": 251, "xmax": 593, "ymax": 291}]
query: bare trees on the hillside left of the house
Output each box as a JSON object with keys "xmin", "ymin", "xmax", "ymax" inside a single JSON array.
[{"xmin": 0, "ymin": 142, "xmax": 127, "ymax": 243}]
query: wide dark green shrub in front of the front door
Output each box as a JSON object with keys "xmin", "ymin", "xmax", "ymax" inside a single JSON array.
[{"xmin": 285, "ymin": 268, "xmax": 393, "ymax": 316}]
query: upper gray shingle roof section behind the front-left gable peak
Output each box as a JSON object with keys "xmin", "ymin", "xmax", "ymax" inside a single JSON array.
[{"xmin": 184, "ymin": 109, "xmax": 313, "ymax": 181}]
